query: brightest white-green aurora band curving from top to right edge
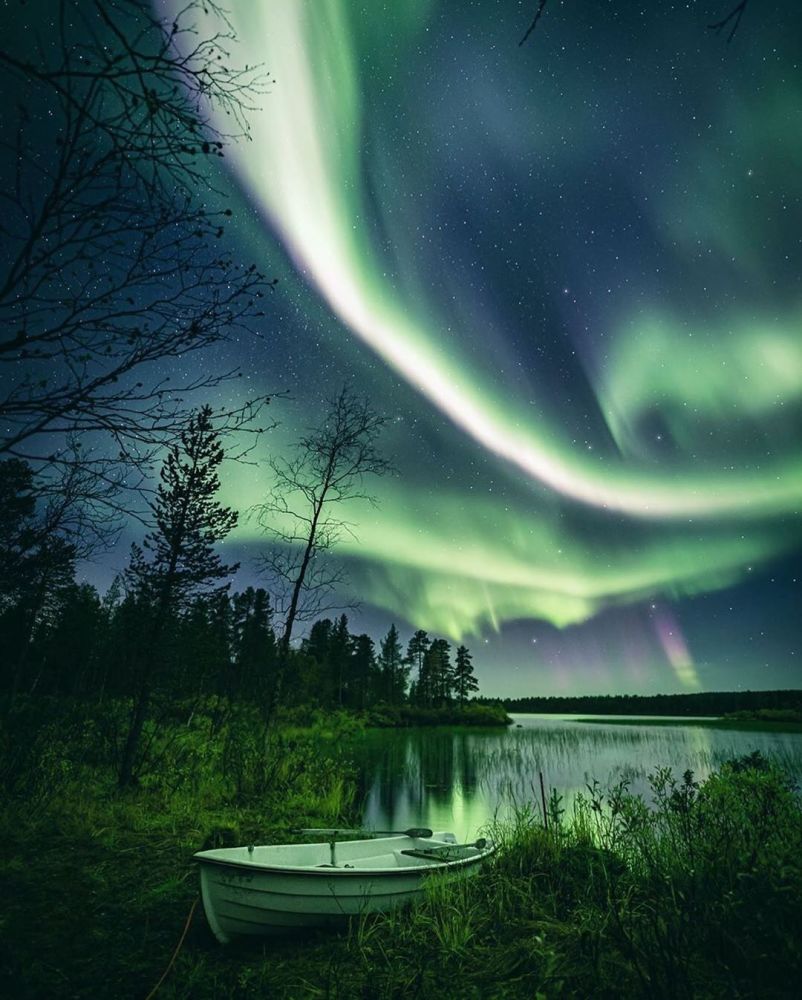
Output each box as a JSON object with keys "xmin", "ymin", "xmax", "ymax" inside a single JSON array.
[{"xmin": 192, "ymin": 0, "xmax": 802, "ymax": 518}]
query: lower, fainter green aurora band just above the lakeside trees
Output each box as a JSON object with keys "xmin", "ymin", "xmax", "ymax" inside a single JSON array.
[{"xmin": 223, "ymin": 458, "xmax": 787, "ymax": 652}]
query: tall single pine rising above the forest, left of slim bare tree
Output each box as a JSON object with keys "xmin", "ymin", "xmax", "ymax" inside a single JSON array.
[{"xmin": 119, "ymin": 406, "xmax": 237, "ymax": 786}]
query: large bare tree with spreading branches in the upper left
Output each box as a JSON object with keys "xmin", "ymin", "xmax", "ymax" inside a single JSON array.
[{"xmin": 0, "ymin": 0, "xmax": 270, "ymax": 488}]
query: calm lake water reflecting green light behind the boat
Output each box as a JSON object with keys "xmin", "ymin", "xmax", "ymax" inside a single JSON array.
[{"xmin": 355, "ymin": 715, "xmax": 802, "ymax": 840}]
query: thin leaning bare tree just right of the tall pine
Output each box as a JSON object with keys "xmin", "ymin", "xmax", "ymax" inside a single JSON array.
[{"xmin": 254, "ymin": 387, "xmax": 390, "ymax": 715}]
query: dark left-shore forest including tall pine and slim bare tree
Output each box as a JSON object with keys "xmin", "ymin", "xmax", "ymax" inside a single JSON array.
[{"xmin": 0, "ymin": 392, "xmax": 492, "ymax": 786}]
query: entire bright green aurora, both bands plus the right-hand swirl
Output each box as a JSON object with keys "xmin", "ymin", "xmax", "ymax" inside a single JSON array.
[{"xmin": 175, "ymin": 0, "xmax": 802, "ymax": 685}]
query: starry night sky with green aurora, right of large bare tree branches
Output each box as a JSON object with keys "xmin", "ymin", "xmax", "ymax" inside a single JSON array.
[{"xmin": 148, "ymin": 0, "xmax": 802, "ymax": 696}]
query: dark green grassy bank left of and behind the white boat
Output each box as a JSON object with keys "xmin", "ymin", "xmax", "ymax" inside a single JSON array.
[{"xmin": 0, "ymin": 700, "xmax": 357, "ymax": 1000}]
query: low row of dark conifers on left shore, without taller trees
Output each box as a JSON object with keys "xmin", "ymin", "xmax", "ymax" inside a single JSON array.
[{"xmin": 0, "ymin": 580, "xmax": 478, "ymax": 710}]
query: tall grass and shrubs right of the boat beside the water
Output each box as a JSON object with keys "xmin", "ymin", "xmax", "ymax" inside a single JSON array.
[{"xmin": 338, "ymin": 754, "xmax": 802, "ymax": 1000}]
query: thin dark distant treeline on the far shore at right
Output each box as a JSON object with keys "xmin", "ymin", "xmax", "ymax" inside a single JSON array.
[{"xmin": 493, "ymin": 689, "xmax": 802, "ymax": 716}]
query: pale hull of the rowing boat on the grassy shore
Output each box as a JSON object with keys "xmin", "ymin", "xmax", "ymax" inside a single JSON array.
[{"xmin": 198, "ymin": 832, "xmax": 490, "ymax": 944}]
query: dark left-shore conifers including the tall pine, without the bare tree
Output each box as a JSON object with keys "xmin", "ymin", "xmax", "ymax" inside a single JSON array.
[{"xmin": 0, "ymin": 438, "xmax": 478, "ymax": 720}]
